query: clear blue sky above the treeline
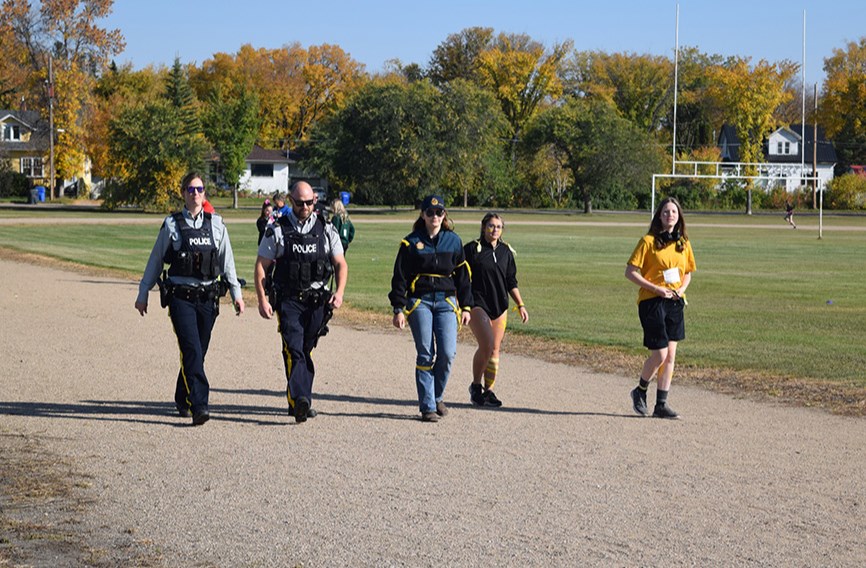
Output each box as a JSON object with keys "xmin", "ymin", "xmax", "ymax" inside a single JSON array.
[{"xmin": 103, "ymin": 0, "xmax": 866, "ymax": 84}]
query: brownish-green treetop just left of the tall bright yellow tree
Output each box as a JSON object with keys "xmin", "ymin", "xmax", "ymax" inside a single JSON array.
[{"xmin": 427, "ymin": 27, "xmax": 493, "ymax": 86}]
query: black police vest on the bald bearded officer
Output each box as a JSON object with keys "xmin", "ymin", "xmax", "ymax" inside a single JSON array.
[{"xmin": 274, "ymin": 216, "xmax": 333, "ymax": 294}]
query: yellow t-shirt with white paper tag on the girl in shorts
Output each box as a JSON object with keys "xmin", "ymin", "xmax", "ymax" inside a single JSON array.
[{"xmin": 628, "ymin": 235, "xmax": 695, "ymax": 303}]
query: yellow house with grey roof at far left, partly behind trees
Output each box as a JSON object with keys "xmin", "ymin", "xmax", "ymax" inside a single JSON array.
[{"xmin": 0, "ymin": 109, "xmax": 91, "ymax": 197}]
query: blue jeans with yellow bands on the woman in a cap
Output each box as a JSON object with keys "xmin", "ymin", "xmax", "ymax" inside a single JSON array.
[{"xmin": 406, "ymin": 292, "xmax": 458, "ymax": 413}]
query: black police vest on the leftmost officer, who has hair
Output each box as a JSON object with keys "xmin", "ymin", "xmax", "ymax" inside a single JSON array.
[{"xmin": 163, "ymin": 213, "xmax": 220, "ymax": 280}]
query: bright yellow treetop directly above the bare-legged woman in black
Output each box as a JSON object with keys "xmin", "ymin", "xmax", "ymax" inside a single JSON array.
[{"xmin": 478, "ymin": 33, "xmax": 571, "ymax": 151}]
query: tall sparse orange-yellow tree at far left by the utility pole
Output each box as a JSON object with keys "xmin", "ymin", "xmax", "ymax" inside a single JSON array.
[{"xmin": 0, "ymin": 0, "xmax": 124, "ymax": 196}]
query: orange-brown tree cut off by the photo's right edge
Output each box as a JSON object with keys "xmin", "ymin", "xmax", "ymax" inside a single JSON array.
[{"xmin": 818, "ymin": 37, "xmax": 866, "ymax": 166}]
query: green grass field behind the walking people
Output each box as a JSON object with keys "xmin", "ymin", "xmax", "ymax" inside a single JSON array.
[{"xmin": 0, "ymin": 210, "xmax": 866, "ymax": 386}]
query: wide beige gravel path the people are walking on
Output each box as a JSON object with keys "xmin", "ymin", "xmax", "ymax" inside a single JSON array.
[{"xmin": 0, "ymin": 261, "xmax": 866, "ymax": 567}]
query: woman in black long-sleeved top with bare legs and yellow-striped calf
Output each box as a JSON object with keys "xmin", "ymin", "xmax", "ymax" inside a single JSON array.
[{"xmin": 463, "ymin": 213, "xmax": 529, "ymax": 408}]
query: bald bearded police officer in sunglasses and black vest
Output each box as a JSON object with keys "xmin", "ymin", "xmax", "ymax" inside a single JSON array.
[{"xmin": 255, "ymin": 181, "xmax": 349, "ymax": 422}]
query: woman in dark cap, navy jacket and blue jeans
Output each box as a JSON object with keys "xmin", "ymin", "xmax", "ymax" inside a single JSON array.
[{"xmin": 388, "ymin": 195, "xmax": 472, "ymax": 422}]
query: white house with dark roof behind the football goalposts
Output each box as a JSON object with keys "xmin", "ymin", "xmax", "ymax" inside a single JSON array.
[{"xmin": 718, "ymin": 124, "xmax": 836, "ymax": 191}]
